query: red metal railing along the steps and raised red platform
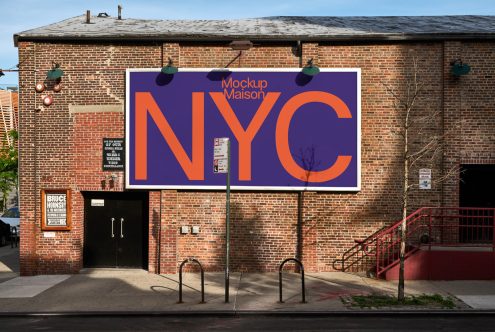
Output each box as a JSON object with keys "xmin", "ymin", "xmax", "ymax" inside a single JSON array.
[{"xmin": 376, "ymin": 208, "xmax": 495, "ymax": 277}]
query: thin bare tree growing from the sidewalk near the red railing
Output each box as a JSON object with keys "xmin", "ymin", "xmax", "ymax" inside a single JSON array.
[{"xmin": 383, "ymin": 56, "xmax": 459, "ymax": 301}]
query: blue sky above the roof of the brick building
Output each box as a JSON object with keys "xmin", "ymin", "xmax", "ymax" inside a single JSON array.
[{"xmin": 0, "ymin": 0, "xmax": 495, "ymax": 88}]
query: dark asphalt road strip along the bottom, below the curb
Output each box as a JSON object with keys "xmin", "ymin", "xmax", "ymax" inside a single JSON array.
[{"xmin": 0, "ymin": 314, "xmax": 495, "ymax": 332}]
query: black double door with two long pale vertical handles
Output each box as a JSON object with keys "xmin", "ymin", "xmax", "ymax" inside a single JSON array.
[{"xmin": 84, "ymin": 193, "xmax": 148, "ymax": 268}]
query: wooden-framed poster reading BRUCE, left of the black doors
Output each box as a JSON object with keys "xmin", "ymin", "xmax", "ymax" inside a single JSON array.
[{"xmin": 41, "ymin": 189, "xmax": 71, "ymax": 231}]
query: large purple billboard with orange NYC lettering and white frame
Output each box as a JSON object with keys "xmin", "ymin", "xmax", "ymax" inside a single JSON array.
[{"xmin": 125, "ymin": 68, "xmax": 361, "ymax": 191}]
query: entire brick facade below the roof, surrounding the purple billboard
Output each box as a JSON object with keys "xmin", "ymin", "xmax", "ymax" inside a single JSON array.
[{"xmin": 19, "ymin": 41, "xmax": 495, "ymax": 275}]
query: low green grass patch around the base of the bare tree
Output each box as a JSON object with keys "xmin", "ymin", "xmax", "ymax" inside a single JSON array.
[{"xmin": 350, "ymin": 294, "xmax": 456, "ymax": 309}]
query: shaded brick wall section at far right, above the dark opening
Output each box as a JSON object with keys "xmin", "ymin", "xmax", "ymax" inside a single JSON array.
[{"xmin": 443, "ymin": 42, "xmax": 495, "ymax": 206}]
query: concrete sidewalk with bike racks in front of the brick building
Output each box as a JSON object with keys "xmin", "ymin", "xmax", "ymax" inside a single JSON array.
[{"xmin": 0, "ymin": 247, "xmax": 495, "ymax": 314}]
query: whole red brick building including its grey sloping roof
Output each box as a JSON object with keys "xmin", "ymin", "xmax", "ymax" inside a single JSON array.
[{"xmin": 14, "ymin": 16, "xmax": 495, "ymax": 275}]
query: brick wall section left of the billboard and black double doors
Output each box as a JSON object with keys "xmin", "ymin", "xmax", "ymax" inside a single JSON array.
[{"xmin": 19, "ymin": 42, "xmax": 161, "ymax": 275}]
